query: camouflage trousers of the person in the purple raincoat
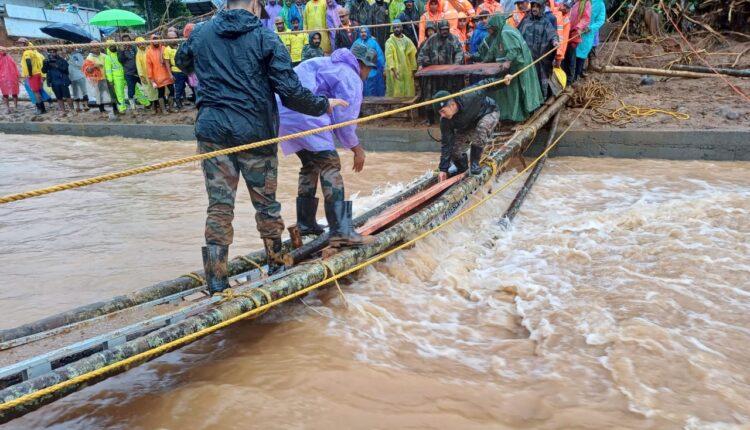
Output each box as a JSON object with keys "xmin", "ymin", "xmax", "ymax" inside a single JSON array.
[{"xmin": 297, "ymin": 149, "xmax": 345, "ymax": 203}]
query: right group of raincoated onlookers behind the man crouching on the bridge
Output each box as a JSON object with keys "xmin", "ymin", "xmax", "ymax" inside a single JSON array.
[{"xmin": 263, "ymin": 0, "xmax": 605, "ymax": 107}]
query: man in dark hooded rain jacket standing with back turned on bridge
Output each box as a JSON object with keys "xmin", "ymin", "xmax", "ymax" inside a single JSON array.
[{"xmin": 176, "ymin": 0, "xmax": 345, "ymax": 294}]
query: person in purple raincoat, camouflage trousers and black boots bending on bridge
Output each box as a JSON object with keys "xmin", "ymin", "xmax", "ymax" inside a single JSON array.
[{"xmin": 277, "ymin": 44, "xmax": 377, "ymax": 247}]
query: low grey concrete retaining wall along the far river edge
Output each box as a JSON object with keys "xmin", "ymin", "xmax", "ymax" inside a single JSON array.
[{"xmin": 0, "ymin": 122, "xmax": 750, "ymax": 161}]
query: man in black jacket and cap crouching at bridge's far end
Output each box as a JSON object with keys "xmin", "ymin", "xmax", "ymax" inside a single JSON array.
[{"xmin": 432, "ymin": 79, "xmax": 500, "ymax": 181}]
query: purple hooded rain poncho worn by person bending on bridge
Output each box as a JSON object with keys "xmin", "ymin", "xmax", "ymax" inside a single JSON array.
[{"xmin": 276, "ymin": 48, "xmax": 362, "ymax": 155}]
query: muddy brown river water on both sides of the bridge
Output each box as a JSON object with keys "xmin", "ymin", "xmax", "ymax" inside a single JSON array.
[{"xmin": 0, "ymin": 135, "xmax": 750, "ymax": 429}]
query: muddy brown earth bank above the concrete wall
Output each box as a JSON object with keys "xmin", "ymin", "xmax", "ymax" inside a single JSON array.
[{"xmin": 5, "ymin": 38, "xmax": 750, "ymax": 133}]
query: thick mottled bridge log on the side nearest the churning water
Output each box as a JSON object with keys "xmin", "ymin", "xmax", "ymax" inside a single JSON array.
[{"xmin": 0, "ymin": 92, "xmax": 570, "ymax": 424}]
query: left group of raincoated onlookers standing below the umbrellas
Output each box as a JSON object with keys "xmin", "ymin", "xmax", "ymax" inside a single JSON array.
[{"xmin": 0, "ymin": 24, "xmax": 198, "ymax": 118}]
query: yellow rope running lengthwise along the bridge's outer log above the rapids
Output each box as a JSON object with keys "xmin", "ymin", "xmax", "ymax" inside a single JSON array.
[{"xmin": 0, "ymin": 95, "xmax": 588, "ymax": 412}]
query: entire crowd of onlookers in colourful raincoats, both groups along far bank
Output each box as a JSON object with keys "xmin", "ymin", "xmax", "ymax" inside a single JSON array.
[{"xmin": 0, "ymin": 0, "xmax": 605, "ymax": 121}]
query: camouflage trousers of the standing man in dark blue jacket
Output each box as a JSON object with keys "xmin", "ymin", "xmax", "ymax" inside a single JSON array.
[{"xmin": 198, "ymin": 141, "xmax": 284, "ymax": 246}]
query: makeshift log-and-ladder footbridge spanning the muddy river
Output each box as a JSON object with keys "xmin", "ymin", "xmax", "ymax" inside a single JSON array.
[{"xmin": 0, "ymin": 87, "xmax": 570, "ymax": 423}]
